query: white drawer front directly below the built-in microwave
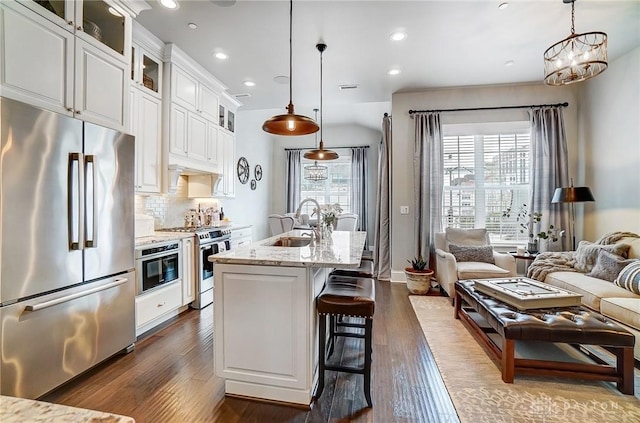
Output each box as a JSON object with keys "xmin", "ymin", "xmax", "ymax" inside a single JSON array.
[{"xmin": 136, "ymin": 280, "xmax": 182, "ymax": 336}]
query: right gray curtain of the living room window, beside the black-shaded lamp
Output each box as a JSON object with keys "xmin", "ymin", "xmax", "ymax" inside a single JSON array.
[{"xmin": 528, "ymin": 107, "xmax": 573, "ymax": 250}]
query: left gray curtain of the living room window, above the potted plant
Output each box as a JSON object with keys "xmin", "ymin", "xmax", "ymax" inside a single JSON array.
[{"xmin": 413, "ymin": 113, "xmax": 444, "ymax": 268}]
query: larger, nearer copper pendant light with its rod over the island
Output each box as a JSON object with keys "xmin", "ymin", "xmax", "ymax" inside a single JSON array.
[{"xmin": 262, "ymin": 0, "xmax": 319, "ymax": 135}]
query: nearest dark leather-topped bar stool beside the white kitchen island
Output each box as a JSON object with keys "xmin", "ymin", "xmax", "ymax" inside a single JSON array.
[{"xmin": 314, "ymin": 275, "xmax": 375, "ymax": 407}]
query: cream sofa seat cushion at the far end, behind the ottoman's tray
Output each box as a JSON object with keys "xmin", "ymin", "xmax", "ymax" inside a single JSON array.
[{"xmin": 544, "ymin": 272, "xmax": 638, "ymax": 311}]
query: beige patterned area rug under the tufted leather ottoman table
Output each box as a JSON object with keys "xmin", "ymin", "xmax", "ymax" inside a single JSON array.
[{"xmin": 409, "ymin": 295, "xmax": 640, "ymax": 423}]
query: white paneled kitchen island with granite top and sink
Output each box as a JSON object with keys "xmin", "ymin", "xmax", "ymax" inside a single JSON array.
[{"xmin": 209, "ymin": 230, "xmax": 366, "ymax": 406}]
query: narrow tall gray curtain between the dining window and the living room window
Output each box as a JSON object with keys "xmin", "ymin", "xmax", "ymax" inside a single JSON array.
[{"xmin": 373, "ymin": 113, "xmax": 391, "ymax": 281}]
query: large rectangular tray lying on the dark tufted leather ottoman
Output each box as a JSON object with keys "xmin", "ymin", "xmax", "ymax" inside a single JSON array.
[{"xmin": 474, "ymin": 277, "xmax": 582, "ymax": 310}]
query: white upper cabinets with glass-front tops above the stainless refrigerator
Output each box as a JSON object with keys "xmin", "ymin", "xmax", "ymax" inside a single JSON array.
[{"xmin": 0, "ymin": 0, "xmax": 148, "ymax": 131}]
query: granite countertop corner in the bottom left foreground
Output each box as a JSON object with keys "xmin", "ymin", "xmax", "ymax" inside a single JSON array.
[{"xmin": 0, "ymin": 395, "xmax": 135, "ymax": 423}]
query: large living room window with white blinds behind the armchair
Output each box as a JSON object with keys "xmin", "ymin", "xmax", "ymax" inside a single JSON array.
[{"xmin": 442, "ymin": 122, "xmax": 531, "ymax": 242}]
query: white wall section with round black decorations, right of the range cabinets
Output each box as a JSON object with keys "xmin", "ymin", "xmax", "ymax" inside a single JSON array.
[{"xmin": 221, "ymin": 109, "xmax": 274, "ymax": 241}]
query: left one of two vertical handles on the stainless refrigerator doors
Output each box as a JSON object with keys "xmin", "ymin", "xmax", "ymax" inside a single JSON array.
[{"xmin": 67, "ymin": 153, "xmax": 84, "ymax": 250}]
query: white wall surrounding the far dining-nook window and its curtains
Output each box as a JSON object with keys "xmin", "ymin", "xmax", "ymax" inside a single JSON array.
[{"xmin": 271, "ymin": 123, "xmax": 382, "ymax": 242}]
